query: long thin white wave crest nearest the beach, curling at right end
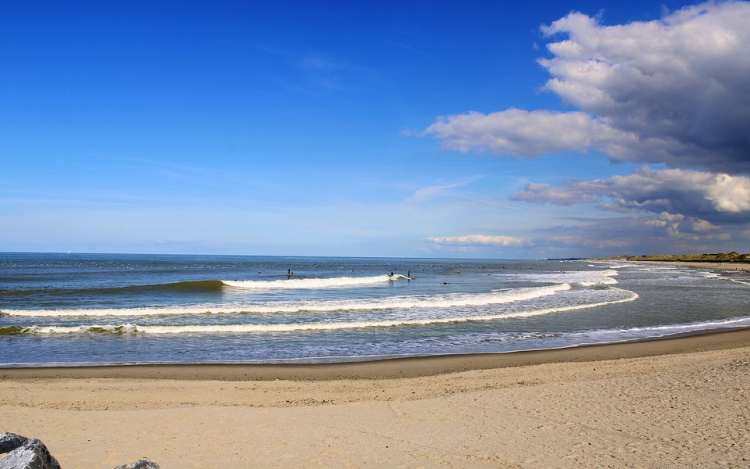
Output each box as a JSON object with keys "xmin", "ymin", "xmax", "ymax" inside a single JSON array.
[{"xmin": 0, "ymin": 290, "xmax": 639, "ymax": 335}]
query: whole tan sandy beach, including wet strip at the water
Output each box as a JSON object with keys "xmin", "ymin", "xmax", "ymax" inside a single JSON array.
[{"xmin": 0, "ymin": 330, "xmax": 750, "ymax": 469}]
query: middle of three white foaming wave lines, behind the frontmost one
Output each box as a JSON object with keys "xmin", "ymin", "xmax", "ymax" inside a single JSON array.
[{"xmin": 2, "ymin": 283, "xmax": 572, "ymax": 317}]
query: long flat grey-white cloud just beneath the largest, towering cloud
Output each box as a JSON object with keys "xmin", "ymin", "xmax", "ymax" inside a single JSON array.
[{"xmin": 511, "ymin": 167, "xmax": 750, "ymax": 222}]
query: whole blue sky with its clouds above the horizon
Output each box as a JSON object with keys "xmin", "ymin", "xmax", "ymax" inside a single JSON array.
[{"xmin": 0, "ymin": 0, "xmax": 750, "ymax": 258}]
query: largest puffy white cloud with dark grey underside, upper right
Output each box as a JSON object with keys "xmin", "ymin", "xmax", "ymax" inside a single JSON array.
[{"xmin": 423, "ymin": 1, "xmax": 750, "ymax": 174}]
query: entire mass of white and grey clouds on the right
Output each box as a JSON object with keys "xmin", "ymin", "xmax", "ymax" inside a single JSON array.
[{"xmin": 422, "ymin": 1, "xmax": 750, "ymax": 251}]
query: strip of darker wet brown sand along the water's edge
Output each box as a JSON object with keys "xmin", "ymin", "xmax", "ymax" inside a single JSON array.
[{"xmin": 0, "ymin": 328, "xmax": 750, "ymax": 381}]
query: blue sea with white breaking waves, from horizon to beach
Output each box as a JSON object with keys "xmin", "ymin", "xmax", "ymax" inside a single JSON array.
[{"xmin": 0, "ymin": 253, "xmax": 750, "ymax": 367}]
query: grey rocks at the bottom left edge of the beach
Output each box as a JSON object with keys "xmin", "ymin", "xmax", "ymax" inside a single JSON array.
[{"xmin": 0, "ymin": 433, "xmax": 159, "ymax": 469}]
